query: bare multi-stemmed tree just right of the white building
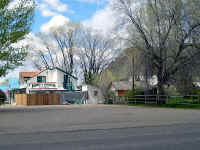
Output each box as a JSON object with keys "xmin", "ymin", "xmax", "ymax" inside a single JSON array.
[{"xmin": 79, "ymin": 29, "xmax": 114, "ymax": 84}]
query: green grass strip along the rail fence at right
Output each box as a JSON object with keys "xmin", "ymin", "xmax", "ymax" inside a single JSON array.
[{"xmin": 127, "ymin": 104, "xmax": 200, "ymax": 109}]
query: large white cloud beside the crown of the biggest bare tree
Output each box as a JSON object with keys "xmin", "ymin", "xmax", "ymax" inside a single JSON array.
[{"xmin": 83, "ymin": 0, "xmax": 130, "ymax": 50}]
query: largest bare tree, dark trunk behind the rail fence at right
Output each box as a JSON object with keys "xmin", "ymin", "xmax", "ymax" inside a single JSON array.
[{"xmin": 114, "ymin": 0, "xmax": 200, "ymax": 94}]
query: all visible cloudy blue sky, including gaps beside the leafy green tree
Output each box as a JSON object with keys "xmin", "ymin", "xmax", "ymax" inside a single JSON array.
[{"xmin": 1, "ymin": 0, "xmax": 117, "ymax": 80}]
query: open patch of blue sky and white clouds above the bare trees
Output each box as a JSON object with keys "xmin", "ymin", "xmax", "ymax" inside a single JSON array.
[{"xmin": 32, "ymin": 0, "xmax": 113, "ymax": 33}]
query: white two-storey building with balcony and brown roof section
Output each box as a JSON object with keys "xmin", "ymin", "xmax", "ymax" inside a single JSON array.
[{"xmin": 20, "ymin": 67, "xmax": 78, "ymax": 93}]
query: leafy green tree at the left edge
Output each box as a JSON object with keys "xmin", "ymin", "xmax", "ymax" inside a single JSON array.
[{"xmin": 0, "ymin": 0, "xmax": 35, "ymax": 77}]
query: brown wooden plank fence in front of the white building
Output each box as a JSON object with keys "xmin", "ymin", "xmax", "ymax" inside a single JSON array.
[{"xmin": 15, "ymin": 93, "xmax": 60, "ymax": 105}]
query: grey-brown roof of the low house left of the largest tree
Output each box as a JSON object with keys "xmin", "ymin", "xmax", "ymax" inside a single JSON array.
[{"xmin": 111, "ymin": 81, "xmax": 132, "ymax": 90}]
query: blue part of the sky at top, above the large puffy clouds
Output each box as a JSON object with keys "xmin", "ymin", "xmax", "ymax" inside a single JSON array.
[{"xmin": 32, "ymin": 0, "xmax": 108, "ymax": 33}]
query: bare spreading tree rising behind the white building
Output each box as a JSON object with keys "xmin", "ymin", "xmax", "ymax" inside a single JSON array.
[{"xmin": 33, "ymin": 23, "xmax": 80, "ymax": 74}]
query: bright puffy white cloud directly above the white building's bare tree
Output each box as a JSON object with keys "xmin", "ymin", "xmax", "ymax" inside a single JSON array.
[{"xmin": 40, "ymin": 15, "xmax": 69, "ymax": 33}]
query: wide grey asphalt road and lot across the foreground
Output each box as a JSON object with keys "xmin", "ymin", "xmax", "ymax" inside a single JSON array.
[{"xmin": 0, "ymin": 105, "xmax": 200, "ymax": 150}]
